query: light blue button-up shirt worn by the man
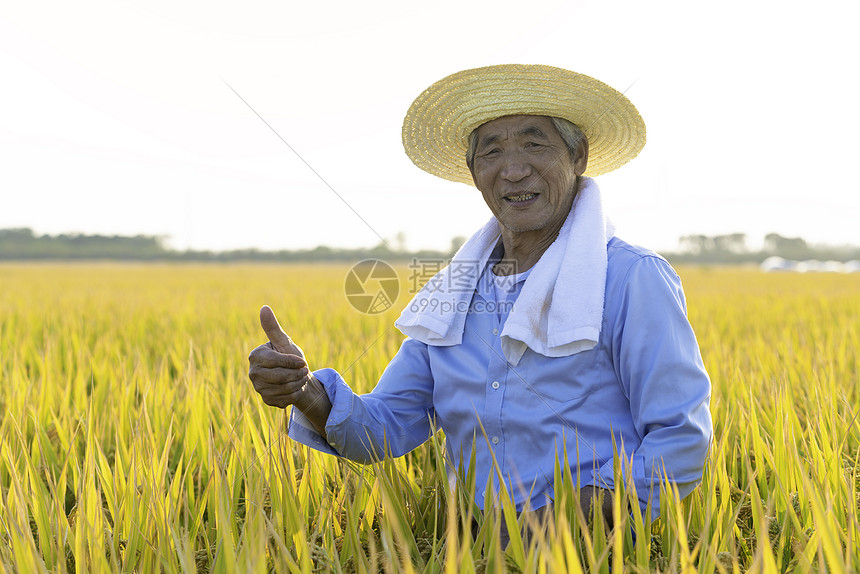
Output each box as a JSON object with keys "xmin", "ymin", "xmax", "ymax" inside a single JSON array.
[{"xmin": 289, "ymin": 238, "xmax": 713, "ymax": 516}]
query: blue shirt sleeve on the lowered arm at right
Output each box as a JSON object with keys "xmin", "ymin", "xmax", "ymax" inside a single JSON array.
[{"xmin": 595, "ymin": 256, "xmax": 713, "ymax": 516}]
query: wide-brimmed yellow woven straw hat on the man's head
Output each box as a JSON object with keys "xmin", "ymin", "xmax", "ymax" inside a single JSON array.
[{"xmin": 403, "ymin": 64, "xmax": 645, "ymax": 185}]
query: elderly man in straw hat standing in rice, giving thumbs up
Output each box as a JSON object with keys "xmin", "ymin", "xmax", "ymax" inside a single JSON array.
[{"xmin": 250, "ymin": 65, "xmax": 712, "ymax": 532}]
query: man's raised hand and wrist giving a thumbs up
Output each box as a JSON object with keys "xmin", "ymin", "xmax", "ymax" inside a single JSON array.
[{"xmin": 248, "ymin": 305, "xmax": 331, "ymax": 437}]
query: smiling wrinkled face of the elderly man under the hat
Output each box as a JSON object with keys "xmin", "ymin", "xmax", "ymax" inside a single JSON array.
[{"xmin": 472, "ymin": 116, "xmax": 587, "ymax": 233}]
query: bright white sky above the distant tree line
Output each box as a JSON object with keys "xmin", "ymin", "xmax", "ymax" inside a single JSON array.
[{"xmin": 0, "ymin": 0, "xmax": 860, "ymax": 251}]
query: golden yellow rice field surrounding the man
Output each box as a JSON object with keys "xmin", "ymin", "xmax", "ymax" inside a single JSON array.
[{"xmin": 0, "ymin": 264, "xmax": 860, "ymax": 574}]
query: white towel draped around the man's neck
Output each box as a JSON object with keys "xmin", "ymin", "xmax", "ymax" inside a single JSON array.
[{"xmin": 394, "ymin": 178, "xmax": 615, "ymax": 365}]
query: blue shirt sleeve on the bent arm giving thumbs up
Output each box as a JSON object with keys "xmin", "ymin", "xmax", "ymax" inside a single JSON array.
[{"xmin": 289, "ymin": 338, "xmax": 435, "ymax": 464}]
